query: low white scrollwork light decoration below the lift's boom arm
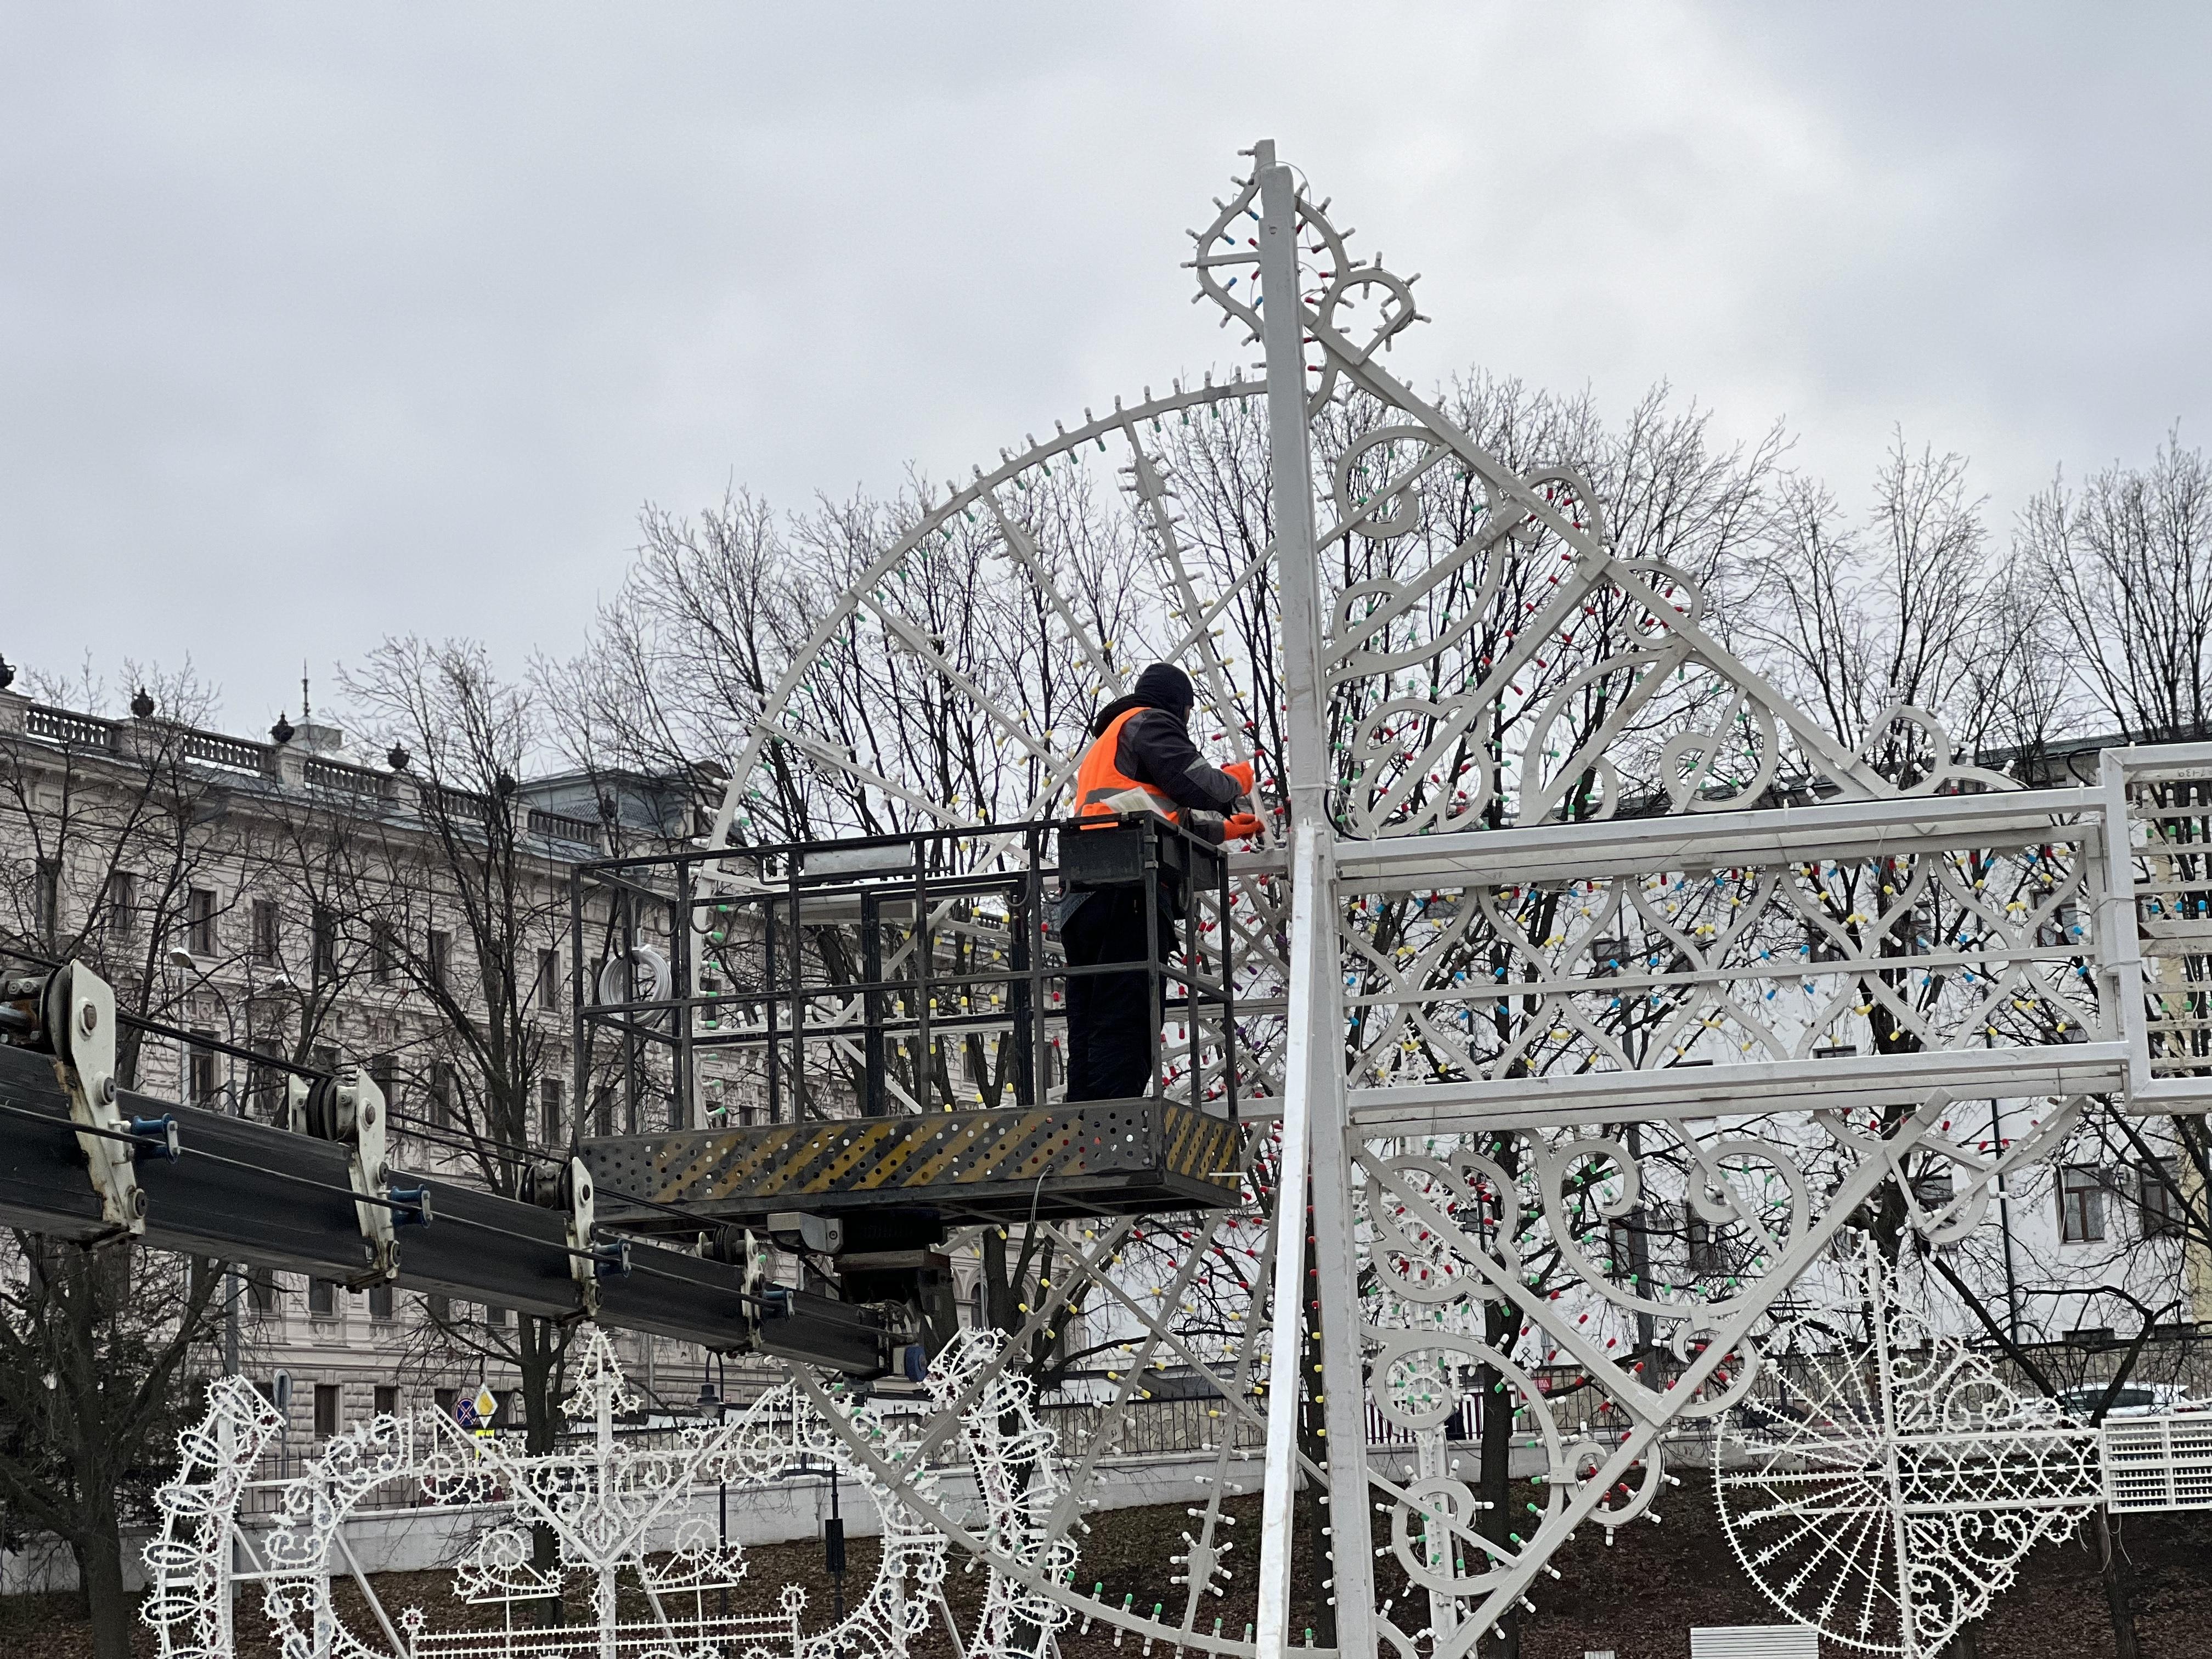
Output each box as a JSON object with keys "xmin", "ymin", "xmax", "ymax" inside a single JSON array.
[{"xmin": 142, "ymin": 1329, "xmax": 1097, "ymax": 1659}]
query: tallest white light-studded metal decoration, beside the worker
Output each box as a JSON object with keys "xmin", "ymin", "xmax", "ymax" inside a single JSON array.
[{"xmin": 654, "ymin": 133, "xmax": 2208, "ymax": 1659}]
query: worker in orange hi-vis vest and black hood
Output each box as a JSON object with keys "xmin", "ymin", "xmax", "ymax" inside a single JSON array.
[{"xmin": 1059, "ymin": 662, "xmax": 1259, "ymax": 1099}]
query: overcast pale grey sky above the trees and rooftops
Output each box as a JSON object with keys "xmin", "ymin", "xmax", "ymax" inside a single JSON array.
[{"xmin": 0, "ymin": 0, "xmax": 2212, "ymax": 730}]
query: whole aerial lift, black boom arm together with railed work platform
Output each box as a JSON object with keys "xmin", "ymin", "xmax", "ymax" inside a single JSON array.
[{"xmin": 0, "ymin": 819, "xmax": 1245, "ymax": 1378}]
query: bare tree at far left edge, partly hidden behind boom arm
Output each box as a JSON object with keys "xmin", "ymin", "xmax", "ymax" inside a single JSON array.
[{"xmin": 0, "ymin": 673, "xmax": 276, "ymax": 1659}]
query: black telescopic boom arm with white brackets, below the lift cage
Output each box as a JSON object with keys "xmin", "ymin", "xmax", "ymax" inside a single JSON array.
[{"xmin": 0, "ymin": 962, "xmax": 918, "ymax": 1376}]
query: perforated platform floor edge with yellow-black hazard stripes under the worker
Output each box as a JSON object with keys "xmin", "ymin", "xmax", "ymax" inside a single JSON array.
[{"xmin": 584, "ymin": 1099, "xmax": 1241, "ymax": 1232}]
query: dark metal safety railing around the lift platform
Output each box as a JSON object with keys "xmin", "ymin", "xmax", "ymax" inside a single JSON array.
[{"xmin": 571, "ymin": 814, "xmax": 1239, "ymax": 1132}]
